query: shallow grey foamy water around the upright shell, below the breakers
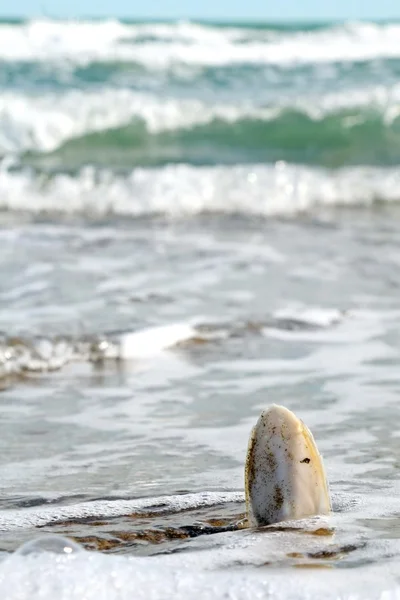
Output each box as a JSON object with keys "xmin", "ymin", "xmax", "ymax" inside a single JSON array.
[{"xmin": 0, "ymin": 209, "xmax": 400, "ymax": 597}]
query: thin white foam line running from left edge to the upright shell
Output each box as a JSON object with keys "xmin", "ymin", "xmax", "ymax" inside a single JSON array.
[{"xmin": 0, "ymin": 492, "xmax": 244, "ymax": 531}]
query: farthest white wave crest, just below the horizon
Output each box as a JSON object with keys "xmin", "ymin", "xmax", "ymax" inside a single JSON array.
[{"xmin": 0, "ymin": 20, "xmax": 400, "ymax": 69}]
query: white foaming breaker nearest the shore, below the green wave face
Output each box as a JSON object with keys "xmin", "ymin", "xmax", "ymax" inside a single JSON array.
[{"xmin": 0, "ymin": 162, "xmax": 400, "ymax": 218}]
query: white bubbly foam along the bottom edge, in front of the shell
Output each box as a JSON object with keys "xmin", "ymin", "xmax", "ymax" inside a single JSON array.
[{"xmin": 0, "ymin": 536, "xmax": 400, "ymax": 600}]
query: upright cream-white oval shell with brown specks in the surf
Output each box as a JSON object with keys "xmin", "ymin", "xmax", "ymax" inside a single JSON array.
[{"xmin": 245, "ymin": 404, "xmax": 331, "ymax": 527}]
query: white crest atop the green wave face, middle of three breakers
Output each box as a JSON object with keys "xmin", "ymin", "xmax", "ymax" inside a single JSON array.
[{"xmin": 0, "ymin": 84, "xmax": 400, "ymax": 154}]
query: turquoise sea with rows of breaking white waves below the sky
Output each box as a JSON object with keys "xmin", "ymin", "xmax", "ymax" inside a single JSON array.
[{"xmin": 0, "ymin": 20, "xmax": 400, "ymax": 214}]
